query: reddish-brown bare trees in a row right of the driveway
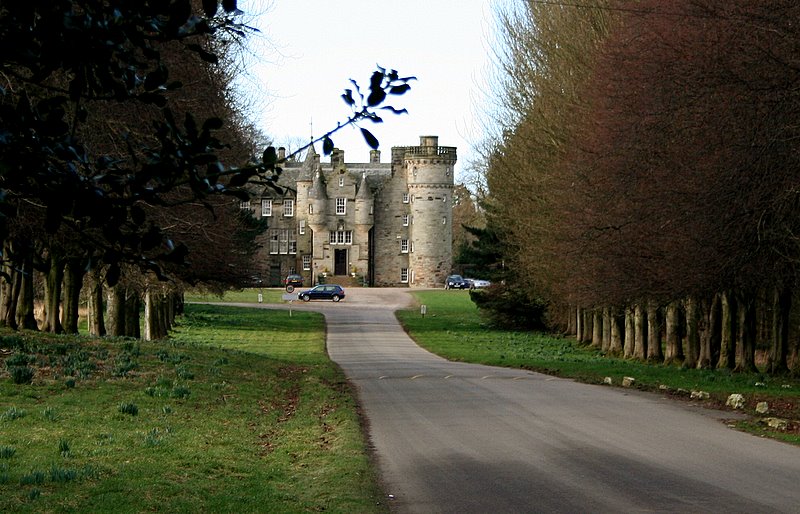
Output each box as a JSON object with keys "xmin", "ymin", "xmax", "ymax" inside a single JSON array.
[{"xmin": 478, "ymin": 0, "xmax": 800, "ymax": 373}]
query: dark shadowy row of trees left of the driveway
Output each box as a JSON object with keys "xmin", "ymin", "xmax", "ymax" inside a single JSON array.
[{"xmin": 0, "ymin": 0, "xmax": 274, "ymax": 339}]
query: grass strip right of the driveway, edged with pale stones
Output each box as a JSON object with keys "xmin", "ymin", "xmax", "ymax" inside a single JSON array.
[{"xmin": 398, "ymin": 291, "xmax": 800, "ymax": 444}]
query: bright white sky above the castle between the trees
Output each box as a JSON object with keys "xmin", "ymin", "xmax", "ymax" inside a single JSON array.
[{"xmin": 234, "ymin": 0, "xmax": 504, "ymax": 181}]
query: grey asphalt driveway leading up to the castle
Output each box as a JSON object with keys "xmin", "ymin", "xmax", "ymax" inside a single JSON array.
[{"xmin": 260, "ymin": 288, "xmax": 800, "ymax": 513}]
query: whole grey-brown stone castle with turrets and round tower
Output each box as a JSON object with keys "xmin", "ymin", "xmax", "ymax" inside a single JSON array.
[{"xmin": 248, "ymin": 136, "xmax": 456, "ymax": 288}]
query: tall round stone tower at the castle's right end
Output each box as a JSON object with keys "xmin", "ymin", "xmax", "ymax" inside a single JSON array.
[{"xmin": 403, "ymin": 136, "xmax": 456, "ymax": 287}]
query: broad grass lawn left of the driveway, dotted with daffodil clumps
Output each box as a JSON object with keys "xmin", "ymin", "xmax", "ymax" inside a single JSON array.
[{"xmin": 0, "ymin": 305, "xmax": 384, "ymax": 512}]
